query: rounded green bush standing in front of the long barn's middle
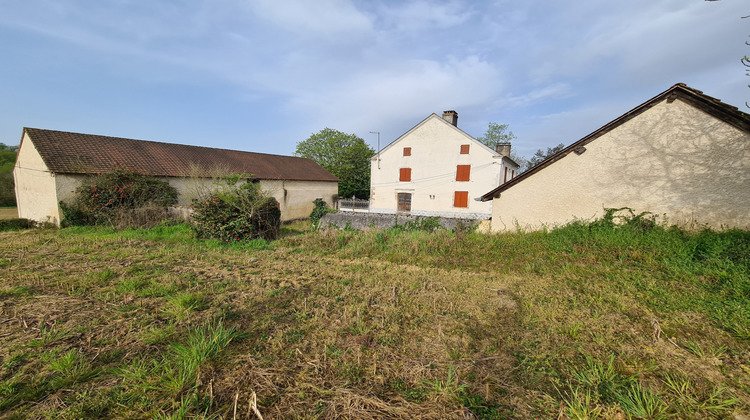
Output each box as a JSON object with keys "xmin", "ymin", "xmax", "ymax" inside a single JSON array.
[{"xmin": 192, "ymin": 175, "xmax": 281, "ymax": 242}]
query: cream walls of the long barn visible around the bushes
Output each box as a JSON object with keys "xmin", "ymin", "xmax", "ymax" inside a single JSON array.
[{"xmin": 13, "ymin": 133, "xmax": 338, "ymax": 225}]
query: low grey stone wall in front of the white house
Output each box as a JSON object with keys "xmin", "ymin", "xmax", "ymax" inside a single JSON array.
[{"xmin": 320, "ymin": 212, "xmax": 489, "ymax": 232}]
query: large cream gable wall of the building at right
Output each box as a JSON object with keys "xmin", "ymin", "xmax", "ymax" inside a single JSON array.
[{"xmin": 492, "ymin": 100, "xmax": 750, "ymax": 231}]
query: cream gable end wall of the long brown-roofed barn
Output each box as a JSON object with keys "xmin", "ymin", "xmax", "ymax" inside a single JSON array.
[{"xmin": 13, "ymin": 134, "xmax": 60, "ymax": 223}]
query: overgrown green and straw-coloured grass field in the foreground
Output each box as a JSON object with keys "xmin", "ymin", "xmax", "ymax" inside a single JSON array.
[{"xmin": 0, "ymin": 224, "xmax": 750, "ymax": 419}]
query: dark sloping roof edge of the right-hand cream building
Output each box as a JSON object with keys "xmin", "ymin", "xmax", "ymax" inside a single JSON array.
[{"xmin": 482, "ymin": 83, "xmax": 750, "ymax": 201}]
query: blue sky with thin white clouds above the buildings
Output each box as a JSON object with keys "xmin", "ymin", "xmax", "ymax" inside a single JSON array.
[{"xmin": 0, "ymin": 0, "xmax": 750, "ymax": 156}]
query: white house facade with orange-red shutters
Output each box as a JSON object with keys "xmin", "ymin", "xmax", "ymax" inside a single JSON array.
[{"xmin": 370, "ymin": 113, "xmax": 518, "ymax": 219}]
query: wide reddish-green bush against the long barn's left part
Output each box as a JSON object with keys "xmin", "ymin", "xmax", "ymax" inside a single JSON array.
[{"xmin": 60, "ymin": 167, "xmax": 177, "ymax": 225}]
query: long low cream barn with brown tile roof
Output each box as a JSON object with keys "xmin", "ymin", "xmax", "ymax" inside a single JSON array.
[{"xmin": 13, "ymin": 128, "xmax": 338, "ymax": 224}]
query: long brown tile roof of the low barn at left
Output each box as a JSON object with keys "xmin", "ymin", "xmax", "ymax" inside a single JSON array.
[{"xmin": 21, "ymin": 128, "xmax": 338, "ymax": 182}]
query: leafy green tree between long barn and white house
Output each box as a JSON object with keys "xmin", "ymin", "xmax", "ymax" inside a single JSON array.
[{"xmin": 294, "ymin": 128, "xmax": 375, "ymax": 199}]
